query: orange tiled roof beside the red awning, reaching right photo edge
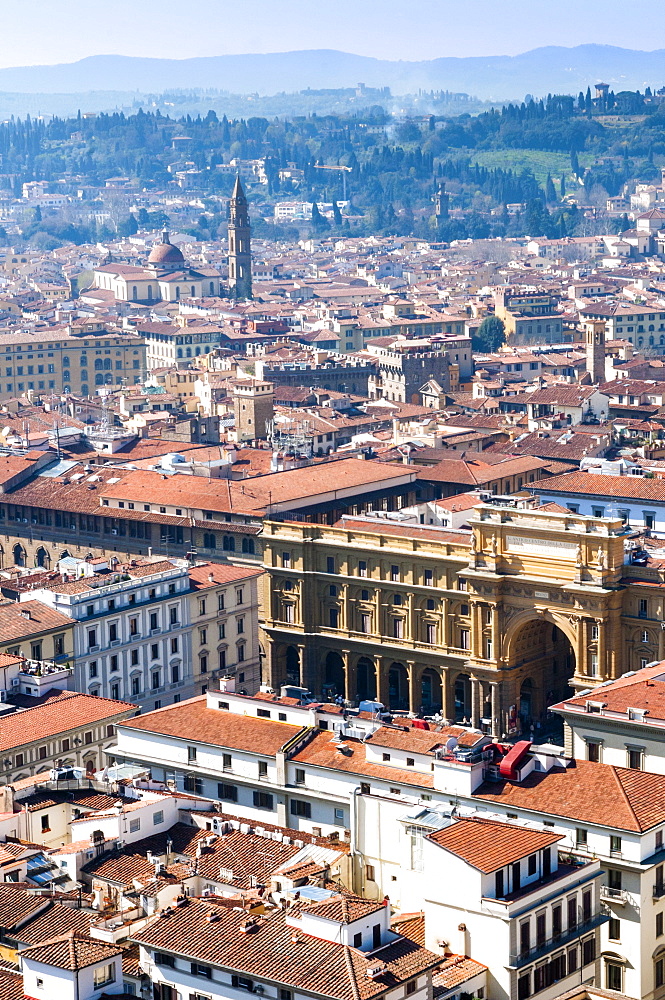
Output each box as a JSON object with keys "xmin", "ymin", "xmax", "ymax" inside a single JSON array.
[{"xmin": 473, "ymin": 760, "xmax": 665, "ymax": 833}]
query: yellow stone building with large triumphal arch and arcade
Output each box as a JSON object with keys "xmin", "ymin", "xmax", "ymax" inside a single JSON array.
[{"xmin": 263, "ymin": 498, "xmax": 665, "ymax": 737}]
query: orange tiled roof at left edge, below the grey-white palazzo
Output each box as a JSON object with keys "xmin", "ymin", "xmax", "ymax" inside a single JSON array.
[{"xmin": 0, "ymin": 692, "xmax": 137, "ymax": 752}]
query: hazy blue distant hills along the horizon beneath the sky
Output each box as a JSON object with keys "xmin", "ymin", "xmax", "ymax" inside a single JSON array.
[{"xmin": 0, "ymin": 45, "xmax": 665, "ymax": 100}]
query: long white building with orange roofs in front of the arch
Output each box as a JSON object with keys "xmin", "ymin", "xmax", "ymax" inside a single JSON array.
[{"xmin": 109, "ymin": 689, "xmax": 665, "ymax": 998}]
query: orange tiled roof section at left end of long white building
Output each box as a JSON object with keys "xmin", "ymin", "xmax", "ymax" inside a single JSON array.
[{"xmin": 118, "ymin": 695, "xmax": 301, "ymax": 756}]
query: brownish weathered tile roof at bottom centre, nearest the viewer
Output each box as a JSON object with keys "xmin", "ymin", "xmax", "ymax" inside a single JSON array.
[{"xmin": 135, "ymin": 899, "xmax": 441, "ymax": 1000}]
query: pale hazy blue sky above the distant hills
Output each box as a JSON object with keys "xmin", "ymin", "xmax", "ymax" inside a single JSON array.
[{"xmin": 6, "ymin": 0, "xmax": 665, "ymax": 66}]
